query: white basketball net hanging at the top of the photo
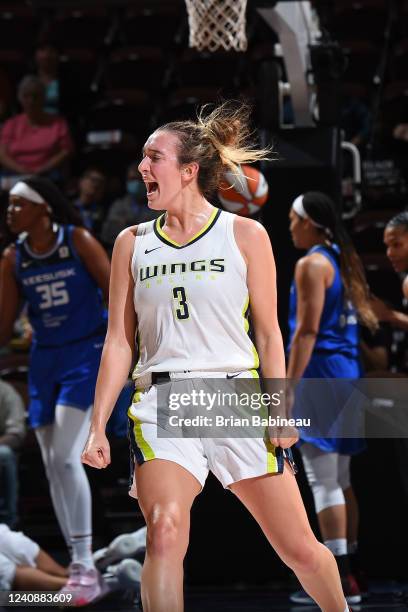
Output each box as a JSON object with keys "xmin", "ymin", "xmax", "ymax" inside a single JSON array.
[{"xmin": 185, "ymin": 0, "xmax": 247, "ymax": 51}]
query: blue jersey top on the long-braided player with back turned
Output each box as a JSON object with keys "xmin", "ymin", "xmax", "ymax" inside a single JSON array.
[{"xmin": 289, "ymin": 244, "xmax": 359, "ymax": 360}]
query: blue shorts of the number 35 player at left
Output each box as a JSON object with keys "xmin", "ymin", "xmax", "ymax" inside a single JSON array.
[{"xmin": 28, "ymin": 335, "xmax": 104, "ymax": 427}]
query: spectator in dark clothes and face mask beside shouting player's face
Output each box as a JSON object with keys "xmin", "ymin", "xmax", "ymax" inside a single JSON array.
[{"xmin": 101, "ymin": 162, "xmax": 159, "ymax": 248}]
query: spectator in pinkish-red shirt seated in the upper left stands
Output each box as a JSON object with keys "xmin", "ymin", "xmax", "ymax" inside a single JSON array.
[{"xmin": 0, "ymin": 76, "xmax": 73, "ymax": 180}]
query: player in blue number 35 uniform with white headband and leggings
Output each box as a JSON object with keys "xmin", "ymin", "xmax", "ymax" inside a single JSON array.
[{"xmin": 0, "ymin": 176, "xmax": 110, "ymax": 603}]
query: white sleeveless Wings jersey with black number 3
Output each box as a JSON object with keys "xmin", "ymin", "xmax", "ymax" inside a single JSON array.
[{"xmin": 132, "ymin": 209, "xmax": 259, "ymax": 379}]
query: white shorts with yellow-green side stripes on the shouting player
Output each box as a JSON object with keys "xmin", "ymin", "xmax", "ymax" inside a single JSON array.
[{"xmin": 128, "ymin": 371, "xmax": 296, "ymax": 498}]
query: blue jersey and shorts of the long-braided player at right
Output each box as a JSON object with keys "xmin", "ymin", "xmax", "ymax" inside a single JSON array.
[{"xmin": 289, "ymin": 245, "xmax": 365, "ymax": 455}]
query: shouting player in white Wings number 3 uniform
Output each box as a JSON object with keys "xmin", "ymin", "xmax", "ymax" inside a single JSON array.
[{"xmin": 83, "ymin": 103, "xmax": 347, "ymax": 612}]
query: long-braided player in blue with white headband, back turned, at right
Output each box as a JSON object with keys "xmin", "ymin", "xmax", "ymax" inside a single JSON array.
[{"xmin": 287, "ymin": 192, "xmax": 376, "ymax": 604}]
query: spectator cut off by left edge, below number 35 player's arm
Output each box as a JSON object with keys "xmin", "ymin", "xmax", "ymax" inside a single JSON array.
[{"xmin": 0, "ymin": 380, "xmax": 25, "ymax": 527}]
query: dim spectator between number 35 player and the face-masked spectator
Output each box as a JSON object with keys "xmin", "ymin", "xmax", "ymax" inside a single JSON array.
[{"xmin": 73, "ymin": 167, "xmax": 106, "ymax": 236}]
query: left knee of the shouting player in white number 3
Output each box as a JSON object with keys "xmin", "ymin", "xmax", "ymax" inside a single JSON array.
[{"xmin": 146, "ymin": 506, "xmax": 183, "ymax": 556}]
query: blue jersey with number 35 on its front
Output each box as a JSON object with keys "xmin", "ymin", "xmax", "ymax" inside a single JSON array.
[{"xmin": 16, "ymin": 226, "xmax": 107, "ymax": 347}]
